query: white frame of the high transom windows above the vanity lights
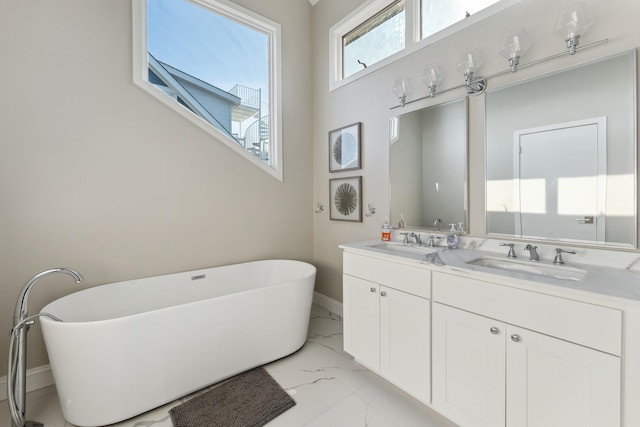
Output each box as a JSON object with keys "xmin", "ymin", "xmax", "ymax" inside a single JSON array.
[{"xmin": 329, "ymin": 0, "xmax": 523, "ymax": 92}]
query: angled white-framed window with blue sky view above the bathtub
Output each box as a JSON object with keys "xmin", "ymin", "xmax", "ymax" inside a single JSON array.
[{"xmin": 134, "ymin": 0, "xmax": 282, "ymax": 180}]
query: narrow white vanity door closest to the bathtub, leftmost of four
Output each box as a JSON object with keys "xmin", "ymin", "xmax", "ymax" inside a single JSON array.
[{"xmin": 342, "ymin": 274, "xmax": 380, "ymax": 372}]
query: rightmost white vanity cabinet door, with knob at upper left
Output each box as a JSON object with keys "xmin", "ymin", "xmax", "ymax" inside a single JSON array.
[{"xmin": 507, "ymin": 326, "xmax": 621, "ymax": 427}]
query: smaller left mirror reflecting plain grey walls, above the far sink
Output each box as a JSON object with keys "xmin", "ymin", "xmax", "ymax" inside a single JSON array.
[{"xmin": 389, "ymin": 98, "xmax": 468, "ymax": 231}]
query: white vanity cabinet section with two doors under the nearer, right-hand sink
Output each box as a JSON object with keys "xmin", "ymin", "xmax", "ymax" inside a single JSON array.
[{"xmin": 432, "ymin": 272, "xmax": 622, "ymax": 427}]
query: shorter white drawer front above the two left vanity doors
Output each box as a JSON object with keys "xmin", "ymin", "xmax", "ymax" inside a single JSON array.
[{"xmin": 342, "ymin": 252, "xmax": 431, "ymax": 298}]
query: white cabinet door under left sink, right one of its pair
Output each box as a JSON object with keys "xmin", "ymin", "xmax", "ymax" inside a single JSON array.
[{"xmin": 380, "ymin": 286, "xmax": 431, "ymax": 403}]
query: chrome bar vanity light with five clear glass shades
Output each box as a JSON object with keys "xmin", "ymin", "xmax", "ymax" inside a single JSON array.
[{"xmin": 390, "ymin": 3, "xmax": 609, "ymax": 110}]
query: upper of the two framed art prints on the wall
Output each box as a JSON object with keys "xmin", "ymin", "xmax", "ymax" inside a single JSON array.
[{"xmin": 329, "ymin": 122, "xmax": 361, "ymax": 172}]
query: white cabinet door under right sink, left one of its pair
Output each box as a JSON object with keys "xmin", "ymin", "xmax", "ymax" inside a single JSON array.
[{"xmin": 432, "ymin": 303, "xmax": 512, "ymax": 427}]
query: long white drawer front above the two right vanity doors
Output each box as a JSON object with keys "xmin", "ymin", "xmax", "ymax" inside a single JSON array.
[{"xmin": 433, "ymin": 272, "xmax": 622, "ymax": 356}]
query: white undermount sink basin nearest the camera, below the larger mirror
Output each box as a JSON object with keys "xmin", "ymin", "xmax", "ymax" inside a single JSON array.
[{"xmin": 467, "ymin": 257, "xmax": 587, "ymax": 281}]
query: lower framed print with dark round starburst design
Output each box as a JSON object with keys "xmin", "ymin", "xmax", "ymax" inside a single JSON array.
[{"xmin": 329, "ymin": 176, "xmax": 362, "ymax": 222}]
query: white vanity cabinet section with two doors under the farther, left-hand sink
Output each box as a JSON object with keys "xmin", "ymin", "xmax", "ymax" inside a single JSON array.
[{"xmin": 343, "ymin": 252, "xmax": 431, "ymax": 403}]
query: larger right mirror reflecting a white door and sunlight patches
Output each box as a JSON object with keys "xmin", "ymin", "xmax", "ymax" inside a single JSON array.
[{"xmin": 486, "ymin": 50, "xmax": 637, "ymax": 247}]
